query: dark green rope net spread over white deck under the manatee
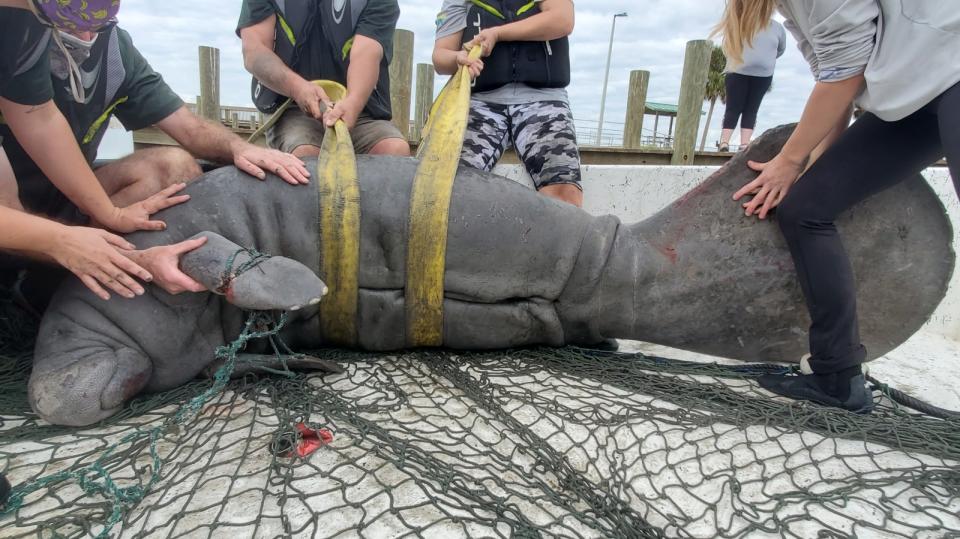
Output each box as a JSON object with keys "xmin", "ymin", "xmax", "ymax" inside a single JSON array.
[{"xmin": 0, "ymin": 288, "xmax": 960, "ymax": 538}]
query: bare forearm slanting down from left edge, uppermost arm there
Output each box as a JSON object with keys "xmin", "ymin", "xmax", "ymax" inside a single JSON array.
[{"xmin": 0, "ymin": 101, "xmax": 115, "ymax": 222}]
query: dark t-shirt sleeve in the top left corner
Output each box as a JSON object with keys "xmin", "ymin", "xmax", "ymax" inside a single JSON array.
[{"xmin": 0, "ymin": 7, "xmax": 53, "ymax": 105}]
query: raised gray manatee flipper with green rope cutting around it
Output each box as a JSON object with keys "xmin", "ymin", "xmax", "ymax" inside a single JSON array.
[{"xmin": 180, "ymin": 232, "xmax": 327, "ymax": 311}]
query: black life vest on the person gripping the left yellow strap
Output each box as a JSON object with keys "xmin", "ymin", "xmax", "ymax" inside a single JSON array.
[{"xmin": 251, "ymin": 0, "xmax": 372, "ymax": 114}]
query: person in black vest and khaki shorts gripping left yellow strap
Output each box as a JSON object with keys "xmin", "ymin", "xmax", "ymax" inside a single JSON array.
[{"xmin": 237, "ymin": 0, "xmax": 410, "ymax": 157}]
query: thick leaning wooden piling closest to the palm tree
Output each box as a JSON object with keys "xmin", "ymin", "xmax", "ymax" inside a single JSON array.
[{"xmin": 671, "ymin": 39, "xmax": 713, "ymax": 165}]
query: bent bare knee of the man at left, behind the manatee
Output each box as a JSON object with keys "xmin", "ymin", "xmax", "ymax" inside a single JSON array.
[{"xmin": 96, "ymin": 148, "xmax": 203, "ymax": 207}]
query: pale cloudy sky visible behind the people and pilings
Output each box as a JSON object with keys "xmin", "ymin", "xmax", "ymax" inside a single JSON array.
[{"xmin": 114, "ymin": 0, "xmax": 813, "ymax": 150}]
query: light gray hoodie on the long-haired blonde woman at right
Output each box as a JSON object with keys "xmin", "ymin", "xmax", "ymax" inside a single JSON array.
[{"xmin": 778, "ymin": 0, "xmax": 960, "ymax": 121}]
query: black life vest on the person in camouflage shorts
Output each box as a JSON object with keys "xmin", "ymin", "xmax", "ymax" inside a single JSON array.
[{"xmin": 463, "ymin": 0, "xmax": 570, "ymax": 92}]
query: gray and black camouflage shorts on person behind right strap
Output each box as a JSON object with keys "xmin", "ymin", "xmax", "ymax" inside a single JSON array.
[{"xmin": 460, "ymin": 99, "xmax": 580, "ymax": 189}]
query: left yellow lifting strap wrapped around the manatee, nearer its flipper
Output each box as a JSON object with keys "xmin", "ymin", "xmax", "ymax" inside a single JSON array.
[{"xmin": 313, "ymin": 80, "xmax": 360, "ymax": 346}]
